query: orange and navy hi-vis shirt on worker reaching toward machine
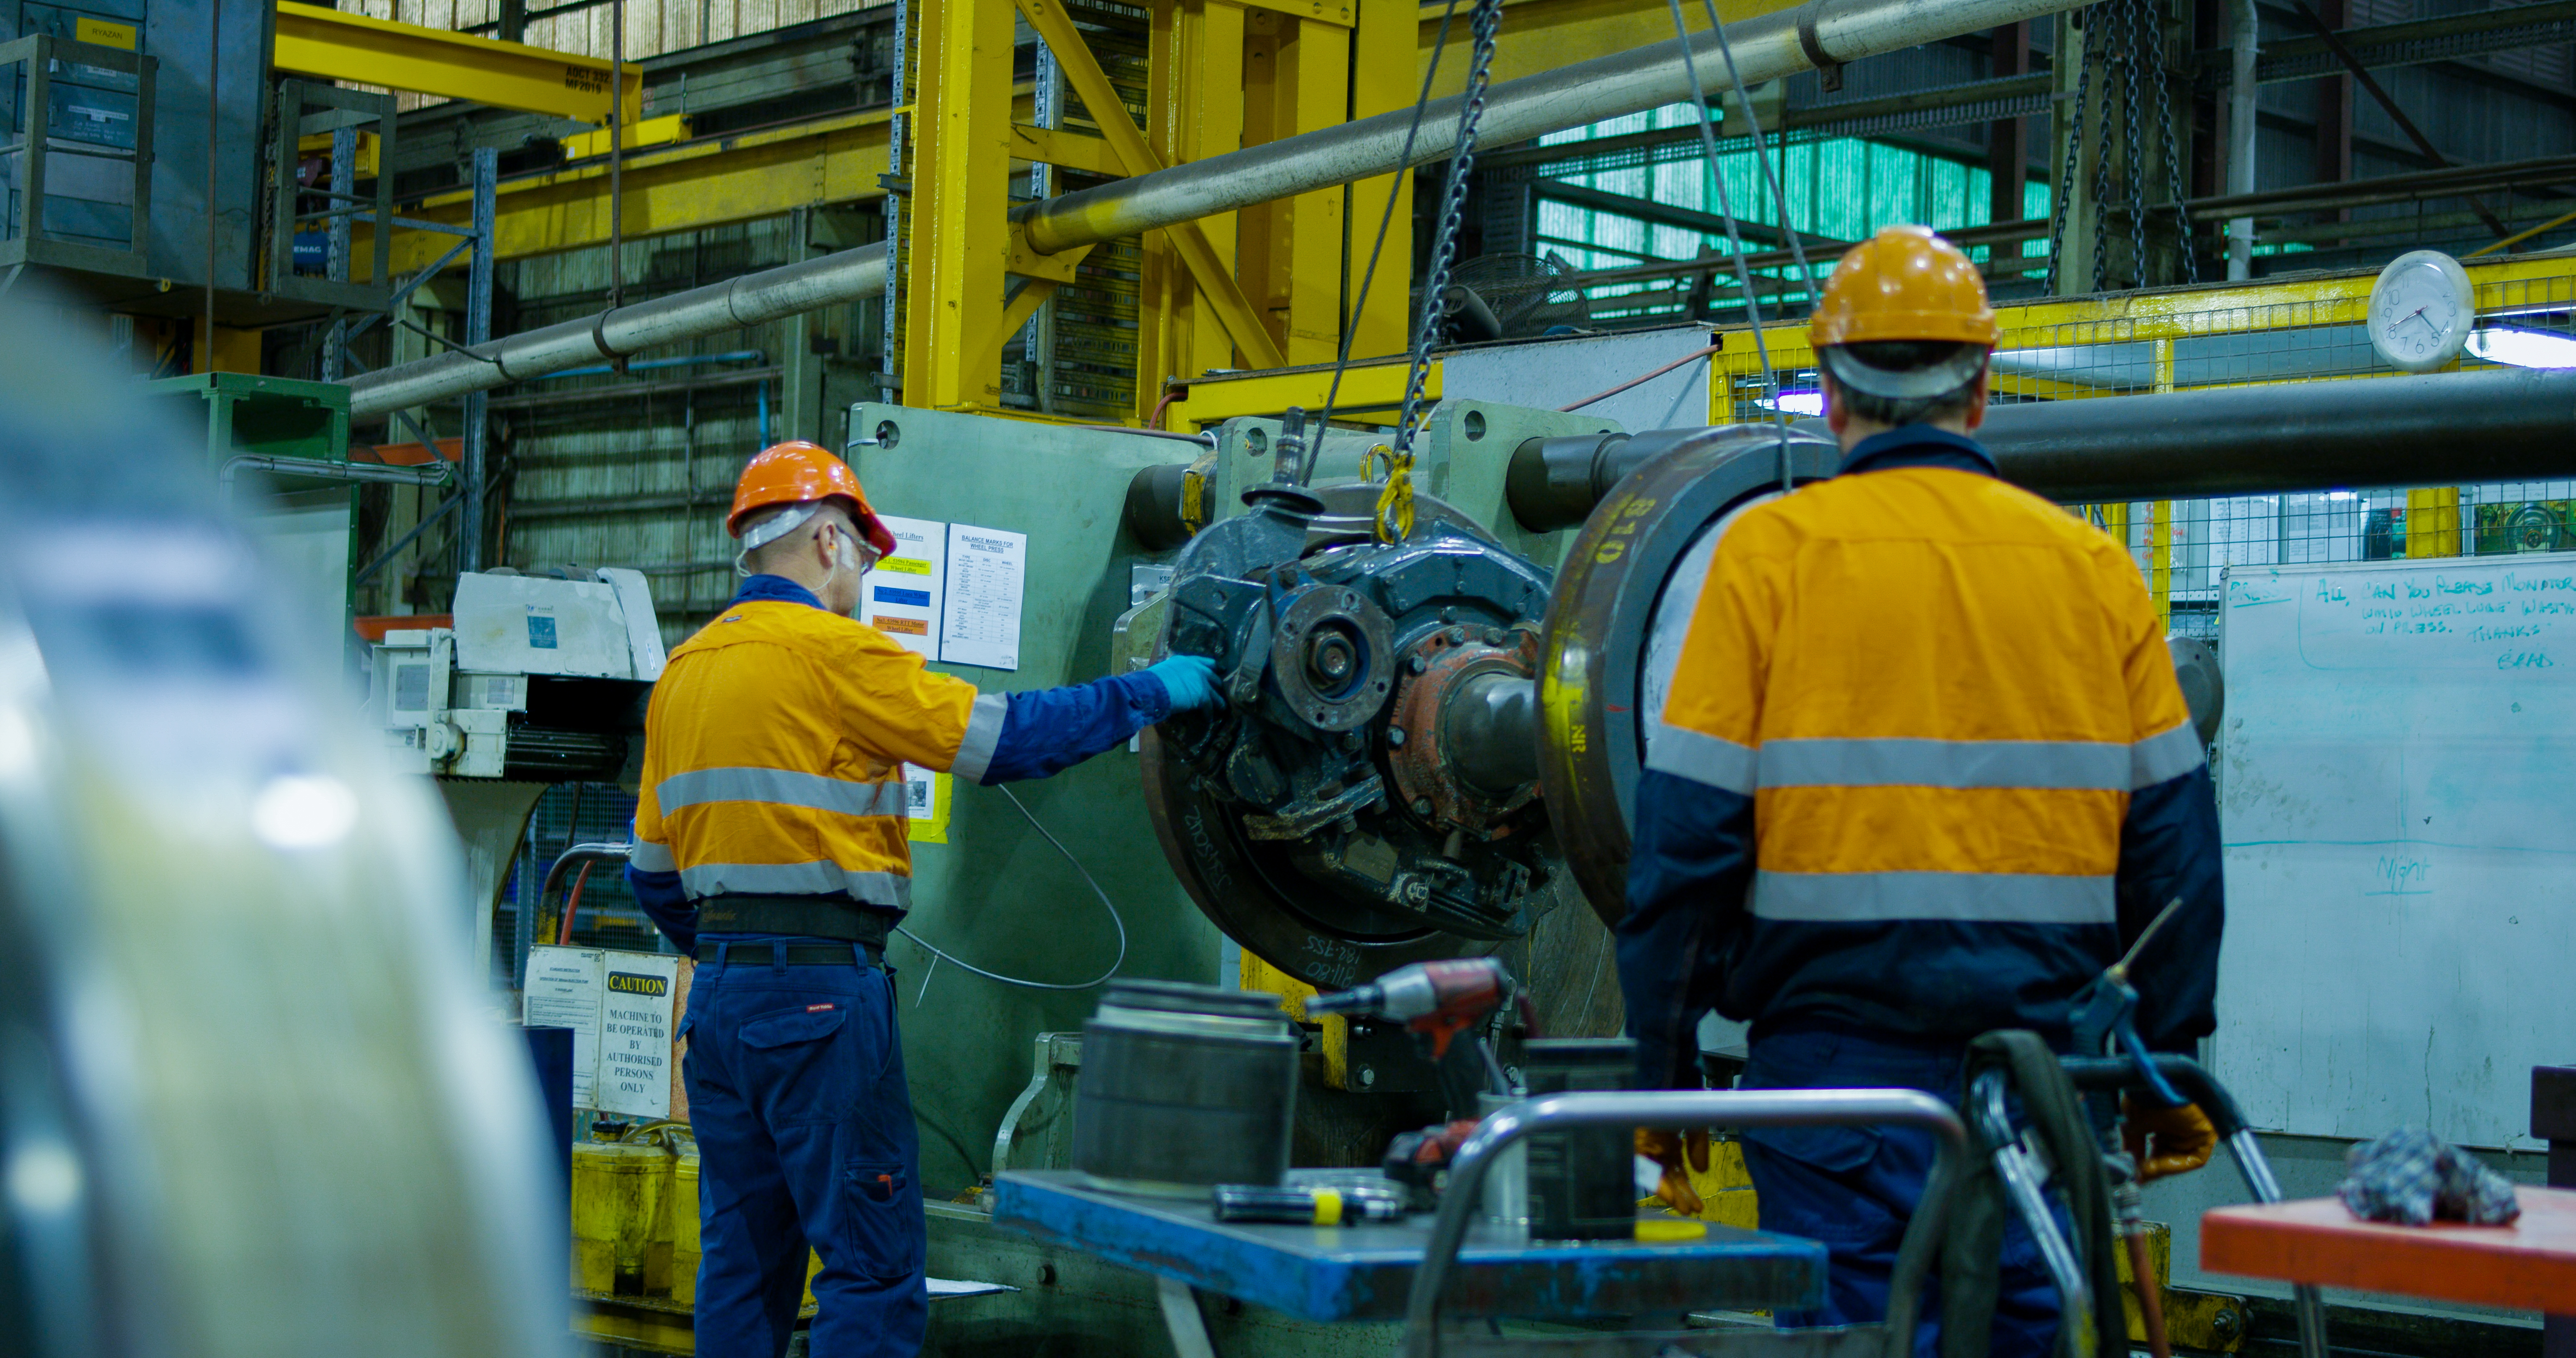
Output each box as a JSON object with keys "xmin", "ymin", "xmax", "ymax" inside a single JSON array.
[{"xmin": 626, "ymin": 575, "xmax": 1172, "ymax": 948}]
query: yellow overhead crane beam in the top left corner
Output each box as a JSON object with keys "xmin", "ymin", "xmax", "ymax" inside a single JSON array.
[{"xmin": 273, "ymin": 0, "xmax": 644, "ymax": 124}]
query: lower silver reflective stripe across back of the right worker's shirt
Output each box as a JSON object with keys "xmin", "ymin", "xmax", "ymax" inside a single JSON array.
[{"xmin": 1754, "ymin": 871, "xmax": 2120, "ymax": 925}]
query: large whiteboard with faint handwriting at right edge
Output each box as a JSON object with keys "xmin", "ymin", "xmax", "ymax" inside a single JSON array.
[{"xmin": 2213, "ymin": 554, "xmax": 2576, "ymax": 1147}]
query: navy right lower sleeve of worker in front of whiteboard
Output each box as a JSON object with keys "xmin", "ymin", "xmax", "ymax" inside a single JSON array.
[{"xmin": 2120, "ymin": 765, "xmax": 2228, "ymax": 1054}]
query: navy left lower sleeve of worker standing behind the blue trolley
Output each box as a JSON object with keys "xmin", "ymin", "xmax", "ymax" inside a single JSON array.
[{"xmin": 1615, "ymin": 770, "xmax": 1754, "ymax": 1090}]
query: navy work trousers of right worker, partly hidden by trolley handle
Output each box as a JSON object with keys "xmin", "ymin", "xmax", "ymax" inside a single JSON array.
[{"xmin": 1739, "ymin": 1028, "xmax": 2066, "ymax": 1358}]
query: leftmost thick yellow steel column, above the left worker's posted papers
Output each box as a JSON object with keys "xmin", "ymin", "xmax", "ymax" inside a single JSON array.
[{"xmin": 904, "ymin": 0, "xmax": 1018, "ymax": 410}]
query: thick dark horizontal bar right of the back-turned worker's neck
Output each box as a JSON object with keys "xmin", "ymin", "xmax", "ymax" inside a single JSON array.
[{"xmin": 1979, "ymin": 368, "xmax": 2576, "ymax": 505}]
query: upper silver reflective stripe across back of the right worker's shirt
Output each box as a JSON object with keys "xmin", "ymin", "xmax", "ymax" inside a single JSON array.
[{"xmin": 1759, "ymin": 737, "xmax": 2130, "ymax": 791}]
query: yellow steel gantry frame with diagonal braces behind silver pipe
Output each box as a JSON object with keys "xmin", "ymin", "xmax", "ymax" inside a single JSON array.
[{"xmin": 886, "ymin": 0, "xmax": 1419, "ymax": 420}]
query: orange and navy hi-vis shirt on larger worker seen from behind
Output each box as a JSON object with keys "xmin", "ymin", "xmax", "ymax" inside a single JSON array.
[{"xmin": 1618, "ymin": 425, "xmax": 2223, "ymax": 1085}]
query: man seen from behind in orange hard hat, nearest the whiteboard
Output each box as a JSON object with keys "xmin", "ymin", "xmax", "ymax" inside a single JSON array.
[{"xmin": 1618, "ymin": 227, "xmax": 2225, "ymax": 1358}]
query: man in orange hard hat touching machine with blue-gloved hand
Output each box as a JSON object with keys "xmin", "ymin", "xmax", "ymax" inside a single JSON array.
[{"xmin": 626, "ymin": 443, "xmax": 1223, "ymax": 1358}]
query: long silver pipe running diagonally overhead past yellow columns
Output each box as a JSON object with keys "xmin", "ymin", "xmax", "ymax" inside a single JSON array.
[{"xmin": 348, "ymin": 0, "xmax": 2066, "ymax": 417}]
